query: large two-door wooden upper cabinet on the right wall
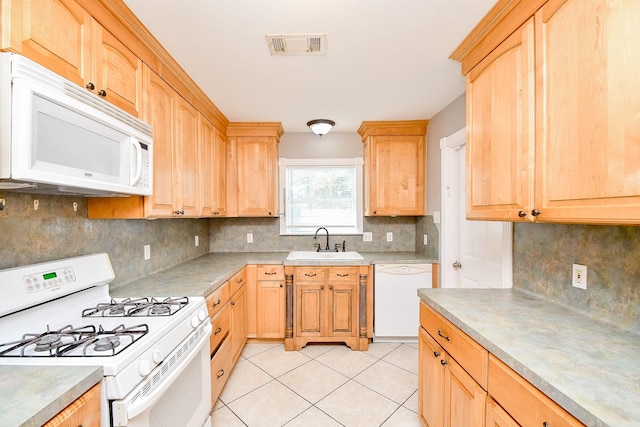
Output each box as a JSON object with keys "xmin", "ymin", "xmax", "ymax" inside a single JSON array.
[{"xmin": 452, "ymin": 0, "xmax": 640, "ymax": 224}]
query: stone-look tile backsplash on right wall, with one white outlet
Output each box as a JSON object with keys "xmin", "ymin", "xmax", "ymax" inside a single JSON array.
[{"xmin": 513, "ymin": 223, "xmax": 640, "ymax": 331}]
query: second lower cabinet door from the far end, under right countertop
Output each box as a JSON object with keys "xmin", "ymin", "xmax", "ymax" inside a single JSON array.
[{"xmin": 444, "ymin": 357, "xmax": 487, "ymax": 427}]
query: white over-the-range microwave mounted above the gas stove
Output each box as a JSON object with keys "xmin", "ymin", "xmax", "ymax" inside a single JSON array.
[{"xmin": 0, "ymin": 53, "xmax": 153, "ymax": 196}]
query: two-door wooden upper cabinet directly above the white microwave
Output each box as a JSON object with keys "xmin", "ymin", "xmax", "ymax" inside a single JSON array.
[{"xmin": 1, "ymin": 0, "xmax": 142, "ymax": 117}]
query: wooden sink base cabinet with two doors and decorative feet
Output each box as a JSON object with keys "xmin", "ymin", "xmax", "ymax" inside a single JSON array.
[{"xmin": 285, "ymin": 266, "xmax": 369, "ymax": 350}]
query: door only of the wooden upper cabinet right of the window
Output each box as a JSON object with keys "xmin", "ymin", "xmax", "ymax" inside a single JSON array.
[{"xmin": 367, "ymin": 135, "xmax": 425, "ymax": 215}]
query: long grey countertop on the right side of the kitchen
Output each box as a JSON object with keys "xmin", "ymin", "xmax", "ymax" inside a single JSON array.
[{"xmin": 418, "ymin": 288, "xmax": 640, "ymax": 427}]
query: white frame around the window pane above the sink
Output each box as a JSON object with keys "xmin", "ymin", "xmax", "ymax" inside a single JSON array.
[{"xmin": 278, "ymin": 157, "xmax": 364, "ymax": 236}]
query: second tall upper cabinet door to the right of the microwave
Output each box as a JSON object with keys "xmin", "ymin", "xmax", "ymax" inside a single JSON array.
[{"xmin": 173, "ymin": 96, "xmax": 201, "ymax": 217}]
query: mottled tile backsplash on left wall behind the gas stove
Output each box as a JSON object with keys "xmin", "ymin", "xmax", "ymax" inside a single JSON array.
[{"xmin": 0, "ymin": 192, "xmax": 209, "ymax": 284}]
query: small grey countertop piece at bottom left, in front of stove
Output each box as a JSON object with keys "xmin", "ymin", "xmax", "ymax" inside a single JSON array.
[{"xmin": 0, "ymin": 366, "xmax": 102, "ymax": 427}]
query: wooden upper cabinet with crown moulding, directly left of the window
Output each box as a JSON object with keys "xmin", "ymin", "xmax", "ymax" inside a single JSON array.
[{"xmin": 227, "ymin": 122, "xmax": 283, "ymax": 217}]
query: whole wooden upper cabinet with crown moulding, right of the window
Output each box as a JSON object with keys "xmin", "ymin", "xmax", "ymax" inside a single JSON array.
[{"xmin": 358, "ymin": 120, "xmax": 428, "ymax": 216}]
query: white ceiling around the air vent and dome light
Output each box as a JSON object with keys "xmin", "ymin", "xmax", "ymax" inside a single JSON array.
[{"xmin": 124, "ymin": 0, "xmax": 496, "ymax": 132}]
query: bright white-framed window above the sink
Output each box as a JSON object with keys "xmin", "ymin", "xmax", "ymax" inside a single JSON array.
[{"xmin": 279, "ymin": 157, "xmax": 363, "ymax": 235}]
